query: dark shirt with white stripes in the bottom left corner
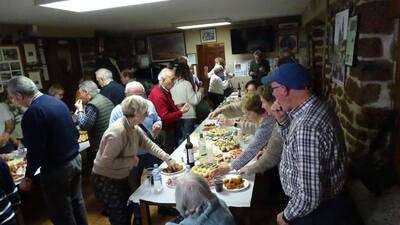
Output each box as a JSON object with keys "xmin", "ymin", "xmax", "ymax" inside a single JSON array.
[{"xmin": 0, "ymin": 160, "xmax": 21, "ymax": 224}]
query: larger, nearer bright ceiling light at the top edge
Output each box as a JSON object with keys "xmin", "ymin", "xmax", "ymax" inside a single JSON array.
[{"xmin": 36, "ymin": 0, "xmax": 169, "ymax": 12}]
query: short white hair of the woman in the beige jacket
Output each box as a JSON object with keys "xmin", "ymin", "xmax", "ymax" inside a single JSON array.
[{"xmin": 121, "ymin": 95, "xmax": 147, "ymax": 117}]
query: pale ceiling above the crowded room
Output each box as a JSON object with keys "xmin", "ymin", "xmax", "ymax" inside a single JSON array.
[{"xmin": 0, "ymin": 0, "xmax": 309, "ymax": 31}]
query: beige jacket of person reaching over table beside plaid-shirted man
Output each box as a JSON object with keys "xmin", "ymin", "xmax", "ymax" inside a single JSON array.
[{"xmin": 247, "ymin": 125, "xmax": 283, "ymax": 174}]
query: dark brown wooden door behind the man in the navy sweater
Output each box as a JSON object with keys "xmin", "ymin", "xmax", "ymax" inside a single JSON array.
[{"xmin": 43, "ymin": 38, "xmax": 82, "ymax": 110}]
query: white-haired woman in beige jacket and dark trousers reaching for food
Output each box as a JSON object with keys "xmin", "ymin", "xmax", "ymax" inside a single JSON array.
[{"xmin": 92, "ymin": 95, "xmax": 176, "ymax": 225}]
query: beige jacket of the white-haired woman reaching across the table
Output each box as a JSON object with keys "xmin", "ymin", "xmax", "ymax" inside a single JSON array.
[{"xmin": 93, "ymin": 117, "xmax": 169, "ymax": 179}]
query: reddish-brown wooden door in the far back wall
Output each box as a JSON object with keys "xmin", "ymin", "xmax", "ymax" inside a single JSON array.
[{"xmin": 196, "ymin": 43, "xmax": 225, "ymax": 81}]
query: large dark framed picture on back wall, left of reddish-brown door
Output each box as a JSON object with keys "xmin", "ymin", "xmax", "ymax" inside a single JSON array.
[{"xmin": 148, "ymin": 32, "xmax": 186, "ymax": 62}]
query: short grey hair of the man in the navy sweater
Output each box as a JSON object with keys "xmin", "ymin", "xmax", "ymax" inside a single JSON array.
[{"xmin": 7, "ymin": 76, "xmax": 39, "ymax": 97}]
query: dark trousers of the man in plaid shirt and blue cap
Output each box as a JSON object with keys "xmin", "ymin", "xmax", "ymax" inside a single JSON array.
[{"xmin": 290, "ymin": 194, "xmax": 351, "ymax": 225}]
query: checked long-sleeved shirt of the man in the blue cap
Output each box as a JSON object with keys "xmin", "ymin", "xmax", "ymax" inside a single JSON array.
[{"xmin": 279, "ymin": 96, "xmax": 346, "ymax": 221}]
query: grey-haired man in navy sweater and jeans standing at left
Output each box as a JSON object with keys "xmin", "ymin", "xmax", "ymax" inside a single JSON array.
[{"xmin": 7, "ymin": 76, "xmax": 88, "ymax": 225}]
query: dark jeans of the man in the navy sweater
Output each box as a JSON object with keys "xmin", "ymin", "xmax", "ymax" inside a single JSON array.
[{"xmin": 40, "ymin": 155, "xmax": 88, "ymax": 225}]
